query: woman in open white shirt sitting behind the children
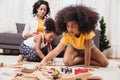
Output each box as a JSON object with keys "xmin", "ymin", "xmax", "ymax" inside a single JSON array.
[{"xmin": 22, "ymin": 0, "xmax": 50, "ymax": 39}]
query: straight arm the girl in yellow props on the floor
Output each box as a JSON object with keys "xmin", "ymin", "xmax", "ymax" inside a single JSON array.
[{"xmin": 84, "ymin": 39, "xmax": 92, "ymax": 66}]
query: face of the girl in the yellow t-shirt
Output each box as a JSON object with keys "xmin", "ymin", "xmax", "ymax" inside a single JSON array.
[{"xmin": 67, "ymin": 21, "xmax": 80, "ymax": 36}]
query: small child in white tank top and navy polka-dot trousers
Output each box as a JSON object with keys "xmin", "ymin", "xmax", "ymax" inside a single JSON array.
[{"xmin": 18, "ymin": 18, "xmax": 57, "ymax": 62}]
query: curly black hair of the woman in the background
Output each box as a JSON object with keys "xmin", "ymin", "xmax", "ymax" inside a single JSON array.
[{"xmin": 32, "ymin": 0, "xmax": 50, "ymax": 17}]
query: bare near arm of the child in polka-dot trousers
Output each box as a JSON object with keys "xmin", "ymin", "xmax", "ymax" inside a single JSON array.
[{"xmin": 34, "ymin": 35, "xmax": 45, "ymax": 59}]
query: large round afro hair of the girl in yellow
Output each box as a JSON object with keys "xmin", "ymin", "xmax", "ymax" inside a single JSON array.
[{"xmin": 55, "ymin": 5, "xmax": 99, "ymax": 34}]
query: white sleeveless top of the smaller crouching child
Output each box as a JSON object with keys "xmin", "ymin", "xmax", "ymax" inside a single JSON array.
[{"xmin": 23, "ymin": 34, "xmax": 48, "ymax": 49}]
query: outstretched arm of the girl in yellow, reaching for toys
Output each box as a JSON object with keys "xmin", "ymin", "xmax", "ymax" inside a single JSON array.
[{"xmin": 38, "ymin": 42, "xmax": 65, "ymax": 67}]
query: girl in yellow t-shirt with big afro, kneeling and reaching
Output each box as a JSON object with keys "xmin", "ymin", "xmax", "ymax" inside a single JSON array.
[{"xmin": 38, "ymin": 5, "xmax": 108, "ymax": 67}]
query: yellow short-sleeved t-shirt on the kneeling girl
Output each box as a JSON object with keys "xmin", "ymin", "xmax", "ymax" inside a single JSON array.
[{"xmin": 60, "ymin": 31, "xmax": 95, "ymax": 50}]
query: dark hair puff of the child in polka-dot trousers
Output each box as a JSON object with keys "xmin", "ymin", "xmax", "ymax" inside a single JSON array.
[{"xmin": 44, "ymin": 18, "xmax": 58, "ymax": 35}]
